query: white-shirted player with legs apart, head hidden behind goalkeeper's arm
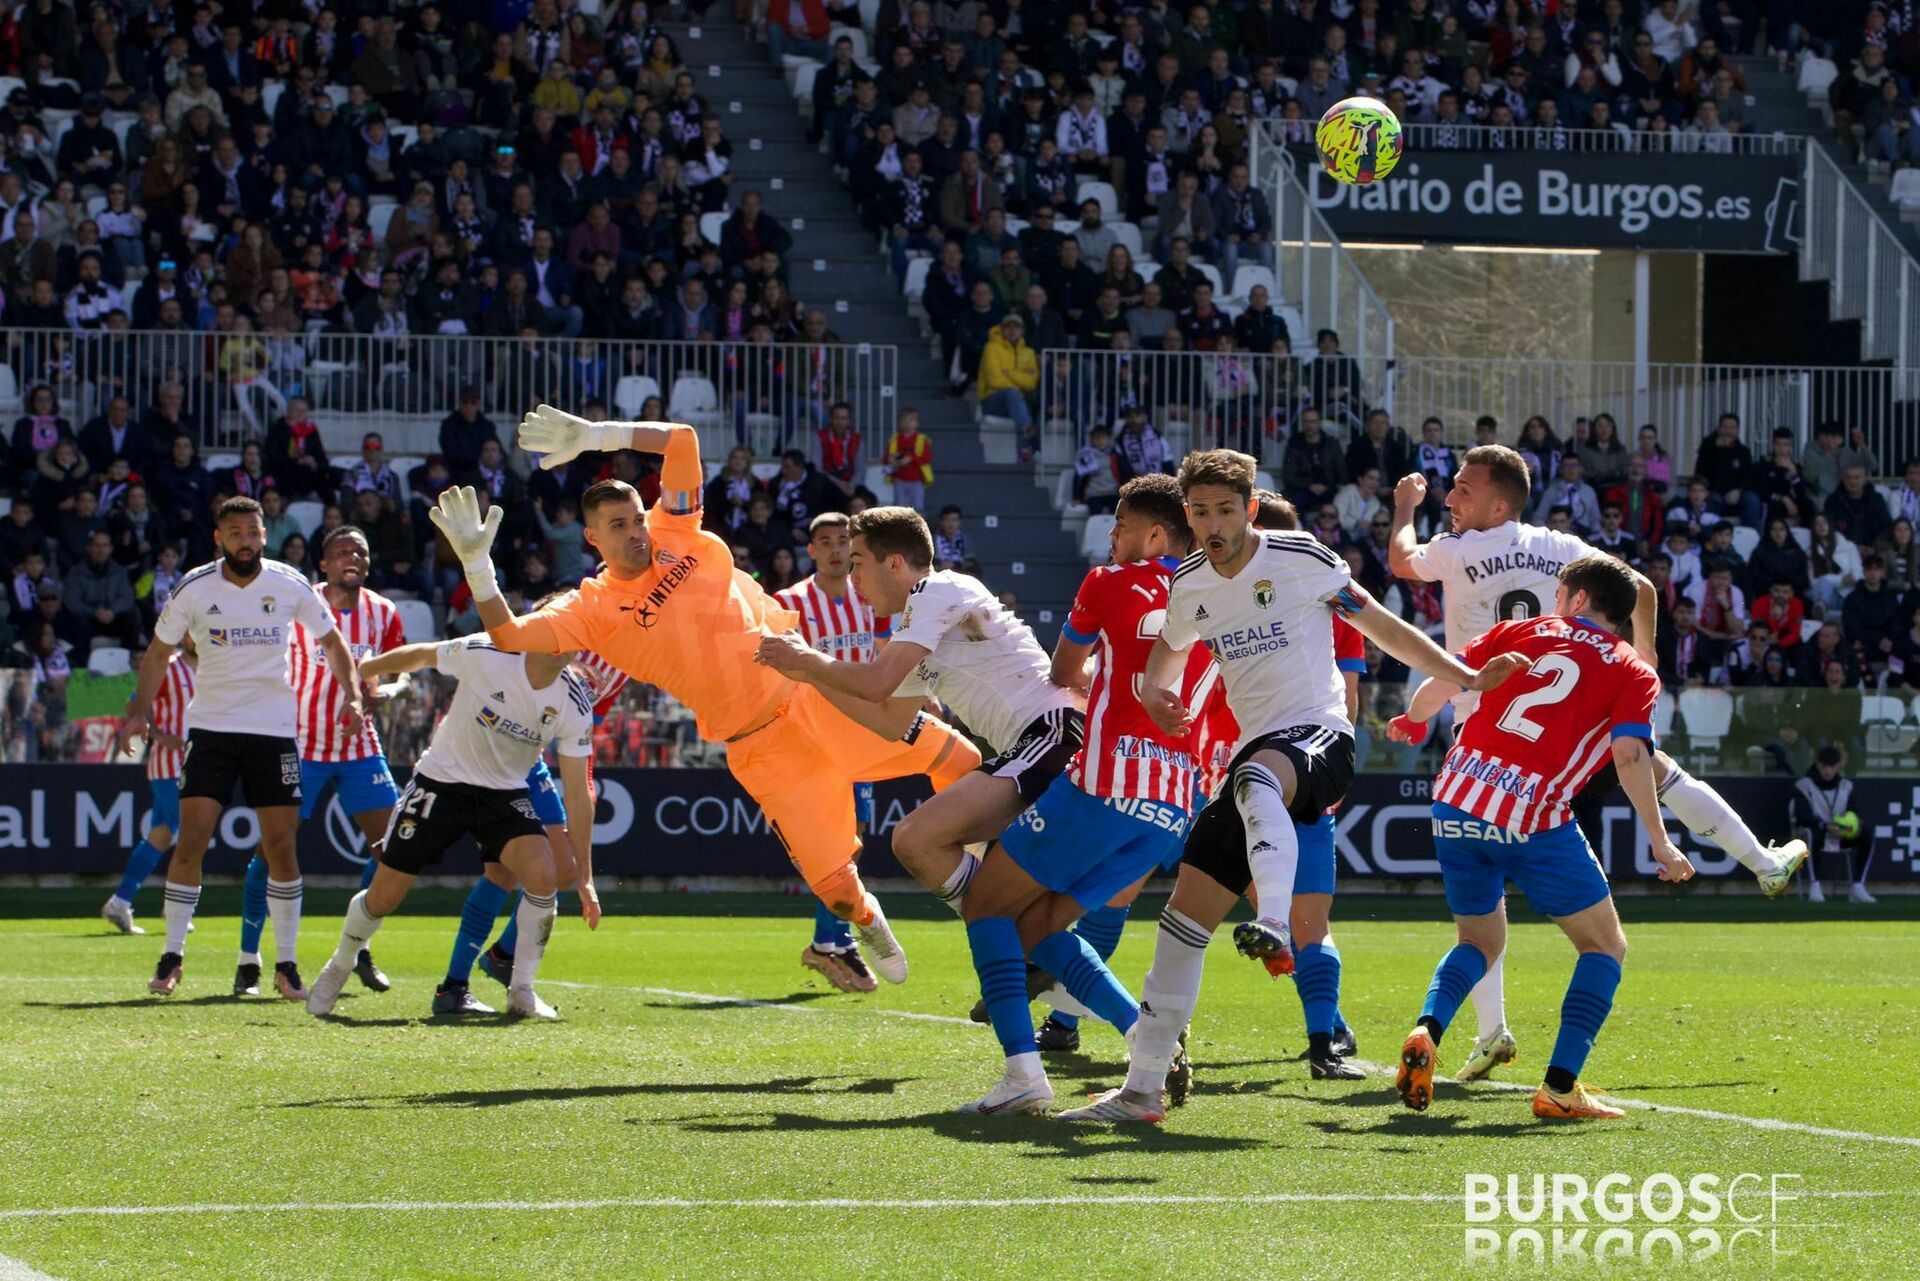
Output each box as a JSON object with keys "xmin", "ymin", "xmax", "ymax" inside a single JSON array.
[{"xmin": 307, "ymin": 636, "xmax": 599, "ymax": 1018}]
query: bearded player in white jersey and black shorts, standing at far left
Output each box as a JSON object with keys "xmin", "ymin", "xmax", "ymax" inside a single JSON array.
[{"xmin": 115, "ymin": 497, "xmax": 365, "ymax": 1001}]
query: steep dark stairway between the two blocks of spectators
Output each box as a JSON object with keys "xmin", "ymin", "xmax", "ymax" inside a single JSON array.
[{"xmin": 668, "ymin": 19, "xmax": 1087, "ymax": 629}]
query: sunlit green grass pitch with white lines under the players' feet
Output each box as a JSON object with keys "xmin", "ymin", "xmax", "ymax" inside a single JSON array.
[{"xmin": 0, "ymin": 889, "xmax": 1920, "ymax": 1281}]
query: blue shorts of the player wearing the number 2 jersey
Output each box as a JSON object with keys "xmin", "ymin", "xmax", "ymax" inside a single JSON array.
[{"xmin": 1434, "ymin": 805, "xmax": 1611, "ymax": 916}]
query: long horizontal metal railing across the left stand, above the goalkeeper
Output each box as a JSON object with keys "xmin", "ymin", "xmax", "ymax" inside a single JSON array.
[{"xmin": 0, "ymin": 330, "xmax": 899, "ymax": 457}]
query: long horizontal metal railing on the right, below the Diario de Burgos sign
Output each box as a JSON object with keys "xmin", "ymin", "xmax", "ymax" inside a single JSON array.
[{"xmin": 1037, "ymin": 350, "xmax": 1920, "ymax": 474}]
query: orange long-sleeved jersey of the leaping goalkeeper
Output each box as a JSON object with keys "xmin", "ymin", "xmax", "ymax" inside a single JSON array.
[{"xmin": 536, "ymin": 432, "xmax": 801, "ymax": 741}]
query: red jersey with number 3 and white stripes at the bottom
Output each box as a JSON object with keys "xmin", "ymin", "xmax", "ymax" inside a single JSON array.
[{"xmin": 1066, "ymin": 559, "xmax": 1213, "ymax": 810}]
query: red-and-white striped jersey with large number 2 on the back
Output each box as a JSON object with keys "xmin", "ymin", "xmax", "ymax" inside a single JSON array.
[{"xmin": 1434, "ymin": 615, "xmax": 1661, "ymax": 835}]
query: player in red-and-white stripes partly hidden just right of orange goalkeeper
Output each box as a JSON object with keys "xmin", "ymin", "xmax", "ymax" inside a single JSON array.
[{"xmin": 774, "ymin": 511, "xmax": 881, "ymax": 991}]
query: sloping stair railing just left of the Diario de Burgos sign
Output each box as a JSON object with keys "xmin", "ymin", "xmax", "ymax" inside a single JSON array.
[{"xmin": 1251, "ymin": 121, "xmax": 1394, "ymax": 386}]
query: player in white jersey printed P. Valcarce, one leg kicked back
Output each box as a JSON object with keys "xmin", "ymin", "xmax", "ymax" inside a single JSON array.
[{"xmin": 1388, "ymin": 446, "xmax": 1807, "ymax": 1081}]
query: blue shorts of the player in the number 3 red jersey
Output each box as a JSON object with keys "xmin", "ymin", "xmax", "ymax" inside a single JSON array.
[{"xmin": 1000, "ymin": 774, "xmax": 1188, "ymax": 912}]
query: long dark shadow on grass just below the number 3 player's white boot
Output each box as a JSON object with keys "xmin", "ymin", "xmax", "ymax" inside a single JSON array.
[{"xmin": 668, "ymin": 1112, "xmax": 1281, "ymax": 1160}]
